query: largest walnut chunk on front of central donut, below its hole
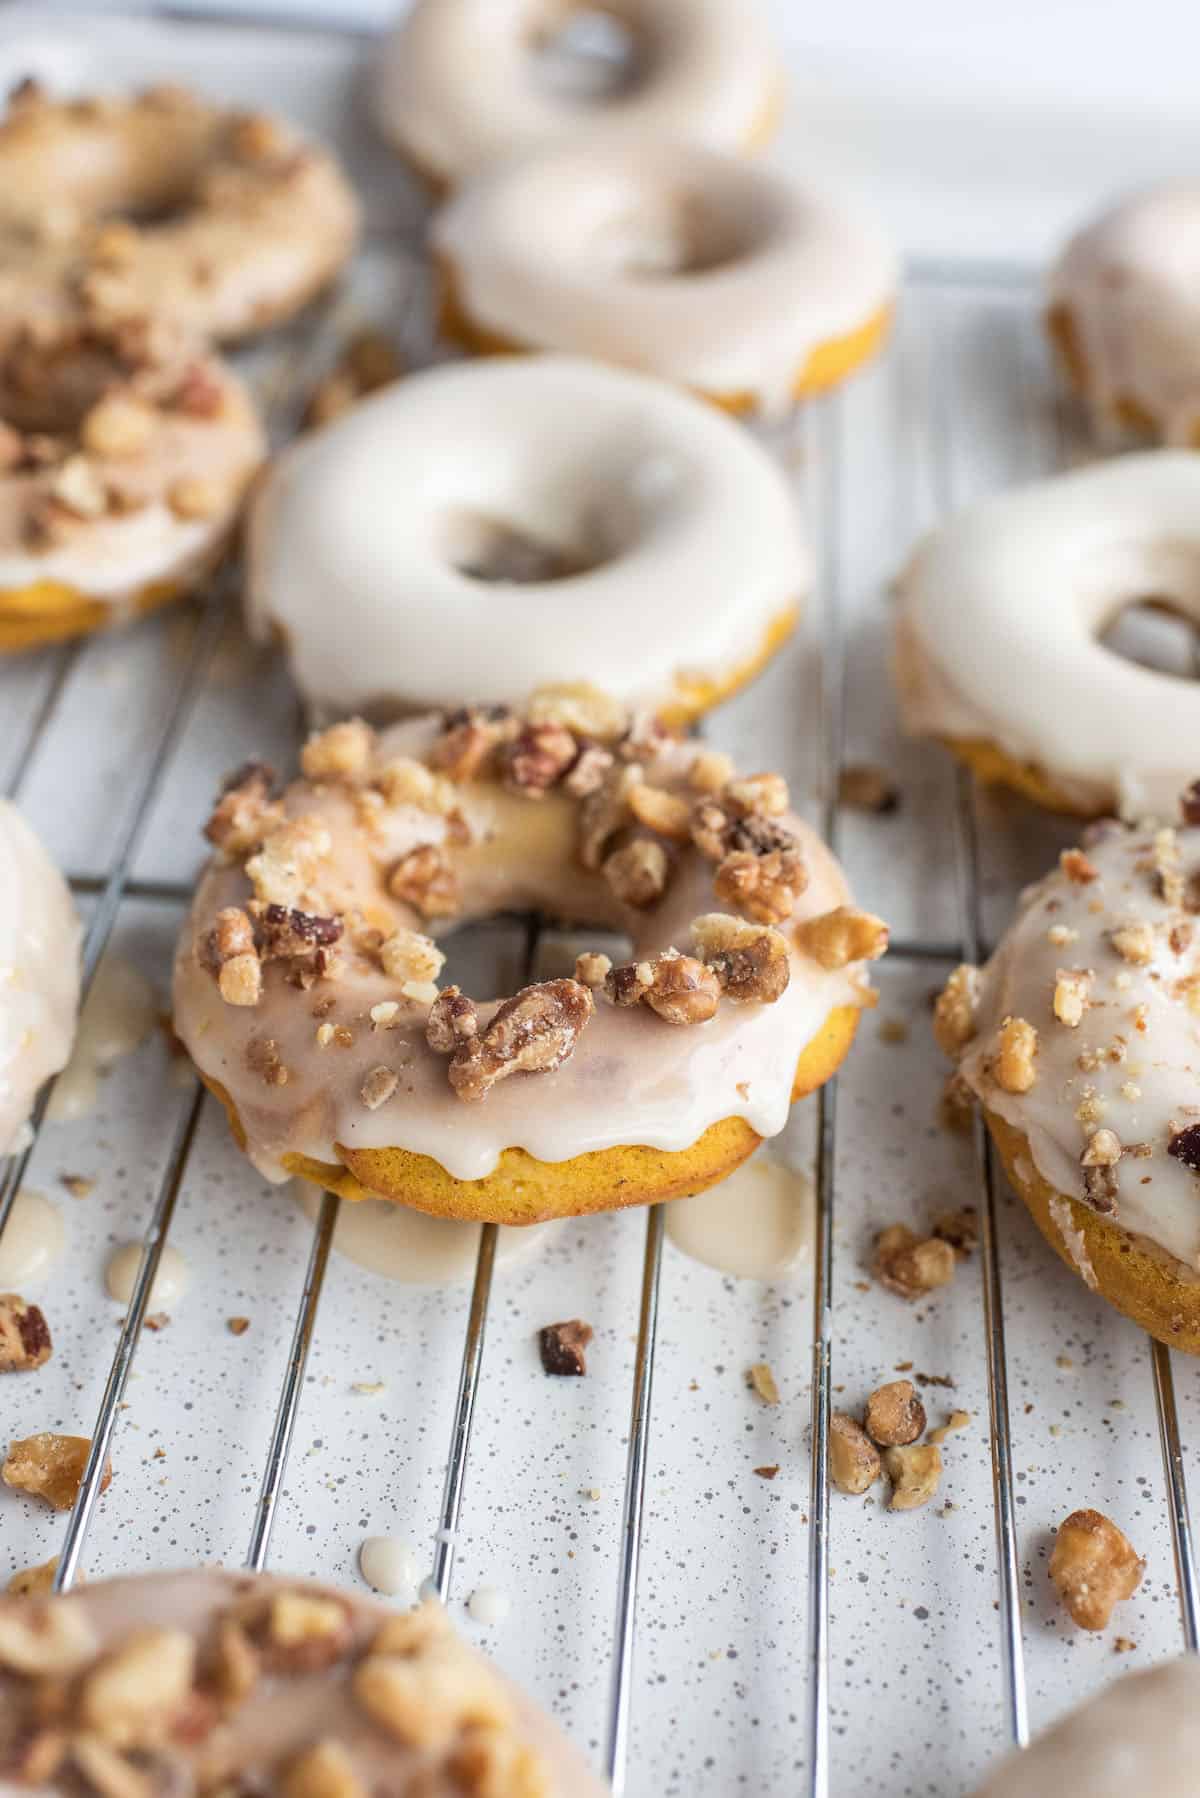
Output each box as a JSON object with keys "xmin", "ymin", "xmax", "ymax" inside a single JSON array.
[{"xmin": 437, "ymin": 980, "xmax": 594, "ymax": 1102}]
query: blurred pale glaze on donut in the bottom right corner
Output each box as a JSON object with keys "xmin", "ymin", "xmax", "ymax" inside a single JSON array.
[{"xmin": 975, "ymin": 1654, "xmax": 1200, "ymax": 1798}]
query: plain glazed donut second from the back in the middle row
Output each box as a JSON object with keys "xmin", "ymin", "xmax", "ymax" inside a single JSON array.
[{"xmin": 432, "ymin": 140, "xmax": 896, "ymax": 412}]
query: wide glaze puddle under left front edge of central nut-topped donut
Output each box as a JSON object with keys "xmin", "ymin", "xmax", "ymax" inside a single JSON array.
[{"xmin": 295, "ymin": 1179, "xmax": 561, "ymax": 1286}]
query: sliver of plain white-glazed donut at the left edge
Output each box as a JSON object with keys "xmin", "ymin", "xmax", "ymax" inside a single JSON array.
[{"xmin": 0, "ymin": 798, "xmax": 79, "ymax": 1158}]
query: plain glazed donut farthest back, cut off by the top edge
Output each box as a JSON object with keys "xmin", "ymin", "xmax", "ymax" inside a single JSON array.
[{"xmin": 372, "ymin": 0, "xmax": 781, "ymax": 187}]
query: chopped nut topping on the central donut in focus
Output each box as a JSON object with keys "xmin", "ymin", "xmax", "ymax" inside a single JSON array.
[{"xmin": 196, "ymin": 697, "xmax": 887, "ymax": 1109}]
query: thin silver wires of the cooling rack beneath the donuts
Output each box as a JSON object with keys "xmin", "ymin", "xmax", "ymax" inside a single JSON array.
[{"xmin": 0, "ymin": 242, "xmax": 1200, "ymax": 1798}]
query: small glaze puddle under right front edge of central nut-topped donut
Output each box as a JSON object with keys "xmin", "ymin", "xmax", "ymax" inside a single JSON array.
[{"xmin": 666, "ymin": 1149, "xmax": 813, "ymax": 1280}]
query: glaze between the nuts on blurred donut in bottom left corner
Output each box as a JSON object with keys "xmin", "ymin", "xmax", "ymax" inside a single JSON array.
[{"xmin": 0, "ymin": 1568, "xmax": 601, "ymax": 1798}]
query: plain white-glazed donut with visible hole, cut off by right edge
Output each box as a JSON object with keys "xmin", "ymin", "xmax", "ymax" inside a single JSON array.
[{"xmin": 894, "ymin": 450, "xmax": 1200, "ymax": 818}]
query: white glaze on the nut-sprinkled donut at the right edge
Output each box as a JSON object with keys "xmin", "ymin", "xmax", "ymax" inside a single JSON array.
[{"xmin": 959, "ymin": 827, "xmax": 1200, "ymax": 1286}]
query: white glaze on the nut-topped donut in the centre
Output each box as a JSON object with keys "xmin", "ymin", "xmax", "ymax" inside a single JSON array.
[{"xmin": 175, "ymin": 721, "xmax": 864, "ymax": 1181}]
